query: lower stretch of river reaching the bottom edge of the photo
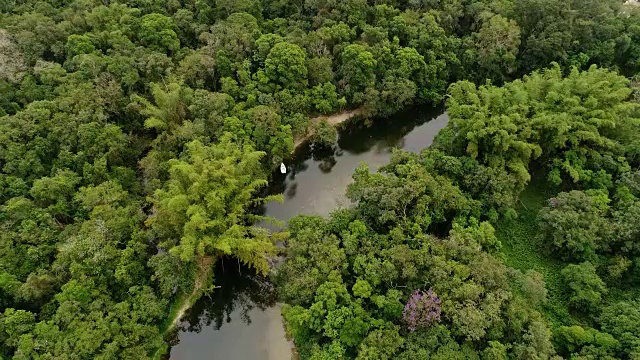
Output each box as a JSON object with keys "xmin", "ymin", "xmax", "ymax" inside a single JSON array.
[{"xmin": 171, "ymin": 258, "xmax": 291, "ymax": 360}]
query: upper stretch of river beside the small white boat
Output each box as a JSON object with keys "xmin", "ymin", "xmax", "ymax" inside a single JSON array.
[{"xmin": 259, "ymin": 108, "xmax": 447, "ymax": 221}]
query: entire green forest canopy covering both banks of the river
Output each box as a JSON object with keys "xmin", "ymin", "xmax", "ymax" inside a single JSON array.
[{"xmin": 0, "ymin": 0, "xmax": 640, "ymax": 359}]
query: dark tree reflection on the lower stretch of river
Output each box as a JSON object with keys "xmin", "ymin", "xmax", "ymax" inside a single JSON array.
[{"xmin": 176, "ymin": 257, "xmax": 276, "ymax": 332}]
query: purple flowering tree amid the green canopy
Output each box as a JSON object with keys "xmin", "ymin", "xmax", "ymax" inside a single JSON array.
[{"xmin": 402, "ymin": 289, "xmax": 442, "ymax": 331}]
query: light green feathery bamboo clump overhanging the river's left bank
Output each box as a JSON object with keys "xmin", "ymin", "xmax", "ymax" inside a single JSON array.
[{"xmin": 149, "ymin": 135, "xmax": 275, "ymax": 273}]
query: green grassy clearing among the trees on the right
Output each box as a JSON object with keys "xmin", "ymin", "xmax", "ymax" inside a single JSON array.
[{"xmin": 496, "ymin": 180, "xmax": 582, "ymax": 328}]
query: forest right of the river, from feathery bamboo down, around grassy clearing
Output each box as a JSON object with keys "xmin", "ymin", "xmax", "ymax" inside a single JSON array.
[{"xmin": 276, "ymin": 66, "xmax": 640, "ymax": 359}]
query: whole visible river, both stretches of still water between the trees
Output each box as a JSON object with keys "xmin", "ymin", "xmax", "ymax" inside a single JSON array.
[{"xmin": 171, "ymin": 108, "xmax": 448, "ymax": 360}]
